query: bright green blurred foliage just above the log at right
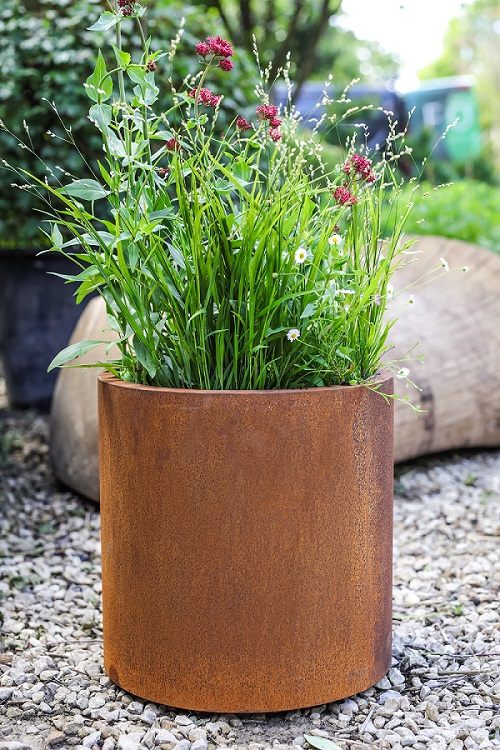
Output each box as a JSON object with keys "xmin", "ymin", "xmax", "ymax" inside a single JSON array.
[{"xmin": 385, "ymin": 180, "xmax": 500, "ymax": 252}]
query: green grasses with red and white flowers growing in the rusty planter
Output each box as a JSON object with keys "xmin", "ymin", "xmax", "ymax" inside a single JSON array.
[{"xmin": 4, "ymin": 0, "xmax": 422, "ymax": 390}]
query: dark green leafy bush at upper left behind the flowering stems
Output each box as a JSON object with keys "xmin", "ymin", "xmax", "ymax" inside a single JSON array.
[{"xmin": 0, "ymin": 0, "xmax": 255, "ymax": 248}]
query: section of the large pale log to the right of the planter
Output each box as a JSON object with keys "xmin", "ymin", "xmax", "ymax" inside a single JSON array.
[{"xmin": 390, "ymin": 236, "xmax": 500, "ymax": 462}]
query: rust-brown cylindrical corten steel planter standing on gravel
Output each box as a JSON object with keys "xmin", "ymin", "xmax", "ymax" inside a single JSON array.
[{"xmin": 99, "ymin": 374, "xmax": 393, "ymax": 713}]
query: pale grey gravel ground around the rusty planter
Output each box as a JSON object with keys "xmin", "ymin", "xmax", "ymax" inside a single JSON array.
[{"xmin": 0, "ymin": 396, "xmax": 500, "ymax": 750}]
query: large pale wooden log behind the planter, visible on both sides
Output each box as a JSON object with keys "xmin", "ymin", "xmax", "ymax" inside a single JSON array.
[{"xmin": 50, "ymin": 236, "xmax": 500, "ymax": 500}]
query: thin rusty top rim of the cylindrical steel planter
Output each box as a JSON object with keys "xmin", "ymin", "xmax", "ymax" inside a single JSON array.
[{"xmin": 98, "ymin": 370, "xmax": 393, "ymax": 397}]
